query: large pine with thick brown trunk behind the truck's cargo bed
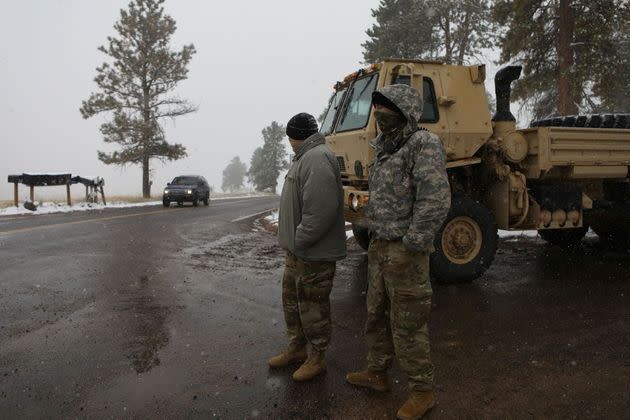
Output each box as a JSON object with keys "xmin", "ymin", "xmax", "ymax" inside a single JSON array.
[{"xmin": 494, "ymin": 0, "xmax": 630, "ymax": 118}]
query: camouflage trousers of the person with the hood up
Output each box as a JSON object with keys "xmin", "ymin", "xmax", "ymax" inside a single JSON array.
[{"xmin": 365, "ymin": 239, "xmax": 433, "ymax": 391}]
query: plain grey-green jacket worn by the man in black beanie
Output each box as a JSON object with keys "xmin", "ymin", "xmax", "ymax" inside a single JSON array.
[{"xmin": 278, "ymin": 133, "xmax": 346, "ymax": 261}]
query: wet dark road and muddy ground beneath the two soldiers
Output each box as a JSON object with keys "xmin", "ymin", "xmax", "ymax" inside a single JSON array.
[{"xmin": 0, "ymin": 198, "xmax": 630, "ymax": 419}]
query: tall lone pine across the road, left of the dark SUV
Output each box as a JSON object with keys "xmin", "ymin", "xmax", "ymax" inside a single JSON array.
[{"xmin": 80, "ymin": 0, "xmax": 196, "ymax": 197}]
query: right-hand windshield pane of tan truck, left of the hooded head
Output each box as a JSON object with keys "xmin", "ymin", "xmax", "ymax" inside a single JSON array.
[{"xmin": 336, "ymin": 73, "xmax": 378, "ymax": 132}]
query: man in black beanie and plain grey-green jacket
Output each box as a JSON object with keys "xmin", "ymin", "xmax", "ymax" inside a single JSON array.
[{"xmin": 269, "ymin": 113, "xmax": 346, "ymax": 381}]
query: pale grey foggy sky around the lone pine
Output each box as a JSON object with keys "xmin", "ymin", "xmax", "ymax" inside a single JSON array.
[{"xmin": 0, "ymin": 0, "xmax": 379, "ymax": 200}]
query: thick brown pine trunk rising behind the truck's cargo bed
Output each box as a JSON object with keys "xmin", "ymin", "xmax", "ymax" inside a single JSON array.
[{"xmin": 558, "ymin": 0, "xmax": 577, "ymax": 115}]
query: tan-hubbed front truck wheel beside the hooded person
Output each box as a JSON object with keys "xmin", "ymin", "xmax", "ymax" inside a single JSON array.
[{"xmin": 431, "ymin": 194, "xmax": 498, "ymax": 284}]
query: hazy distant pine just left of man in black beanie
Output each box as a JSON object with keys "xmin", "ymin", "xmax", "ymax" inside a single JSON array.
[{"xmin": 247, "ymin": 121, "xmax": 289, "ymax": 194}]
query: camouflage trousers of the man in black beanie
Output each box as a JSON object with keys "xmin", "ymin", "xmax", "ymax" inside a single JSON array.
[{"xmin": 282, "ymin": 252, "xmax": 336, "ymax": 353}]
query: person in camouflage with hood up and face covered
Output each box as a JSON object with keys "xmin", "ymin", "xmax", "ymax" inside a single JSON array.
[{"xmin": 346, "ymin": 85, "xmax": 451, "ymax": 419}]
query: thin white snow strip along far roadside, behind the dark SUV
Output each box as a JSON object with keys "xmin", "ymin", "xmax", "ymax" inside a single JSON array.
[{"xmin": 0, "ymin": 195, "xmax": 272, "ymax": 217}]
